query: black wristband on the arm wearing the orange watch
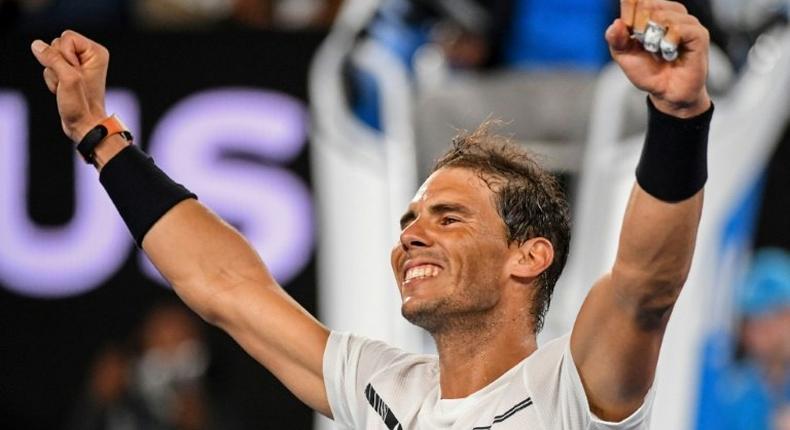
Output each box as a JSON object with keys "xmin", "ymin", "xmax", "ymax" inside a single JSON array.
[{"xmin": 99, "ymin": 145, "xmax": 197, "ymax": 247}]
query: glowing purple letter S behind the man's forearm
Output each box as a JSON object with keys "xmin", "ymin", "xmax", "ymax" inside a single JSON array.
[{"xmin": 141, "ymin": 88, "xmax": 313, "ymax": 284}]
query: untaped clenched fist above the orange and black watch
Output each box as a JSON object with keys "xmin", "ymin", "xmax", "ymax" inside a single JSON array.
[{"xmin": 31, "ymin": 30, "xmax": 110, "ymax": 143}]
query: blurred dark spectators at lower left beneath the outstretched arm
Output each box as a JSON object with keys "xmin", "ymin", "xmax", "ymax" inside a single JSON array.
[{"xmin": 67, "ymin": 303, "xmax": 235, "ymax": 430}]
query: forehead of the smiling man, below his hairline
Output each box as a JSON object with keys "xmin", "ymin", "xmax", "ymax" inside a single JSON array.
[{"xmin": 410, "ymin": 167, "xmax": 493, "ymax": 209}]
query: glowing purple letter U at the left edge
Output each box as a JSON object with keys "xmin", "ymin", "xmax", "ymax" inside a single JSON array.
[{"xmin": 0, "ymin": 91, "xmax": 139, "ymax": 298}]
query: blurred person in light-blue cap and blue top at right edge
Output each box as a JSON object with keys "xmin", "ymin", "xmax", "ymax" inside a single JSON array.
[{"xmin": 697, "ymin": 248, "xmax": 790, "ymax": 430}]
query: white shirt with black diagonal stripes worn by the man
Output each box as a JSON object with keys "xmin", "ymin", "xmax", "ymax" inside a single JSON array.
[{"xmin": 324, "ymin": 332, "xmax": 653, "ymax": 430}]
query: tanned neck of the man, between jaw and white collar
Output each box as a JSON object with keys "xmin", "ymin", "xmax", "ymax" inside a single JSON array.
[{"xmin": 431, "ymin": 309, "xmax": 537, "ymax": 399}]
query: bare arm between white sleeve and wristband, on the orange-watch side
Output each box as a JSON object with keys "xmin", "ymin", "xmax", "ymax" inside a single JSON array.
[{"xmin": 143, "ymin": 199, "xmax": 331, "ymax": 416}]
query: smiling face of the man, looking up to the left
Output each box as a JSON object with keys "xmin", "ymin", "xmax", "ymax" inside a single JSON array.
[{"xmin": 392, "ymin": 168, "xmax": 510, "ymax": 333}]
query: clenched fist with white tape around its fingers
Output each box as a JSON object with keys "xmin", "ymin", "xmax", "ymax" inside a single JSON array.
[{"xmin": 606, "ymin": 0, "xmax": 710, "ymax": 118}]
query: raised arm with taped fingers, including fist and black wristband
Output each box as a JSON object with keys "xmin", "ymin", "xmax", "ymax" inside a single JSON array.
[{"xmin": 571, "ymin": 0, "xmax": 712, "ymax": 421}]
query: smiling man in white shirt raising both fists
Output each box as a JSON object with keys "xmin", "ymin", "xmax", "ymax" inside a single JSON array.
[{"xmin": 32, "ymin": 0, "xmax": 712, "ymax": 429}]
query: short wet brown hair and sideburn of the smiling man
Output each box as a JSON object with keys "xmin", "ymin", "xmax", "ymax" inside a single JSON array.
[{"xmin": 433, "ymin": 120, "xmax": 571, "ymax": 333}]
